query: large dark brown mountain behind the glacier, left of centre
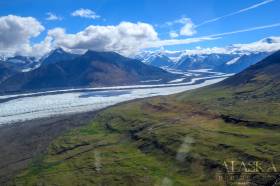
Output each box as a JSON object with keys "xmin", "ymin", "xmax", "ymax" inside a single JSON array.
[{"xmin": 0, "ymin": 51, "xmax": 176, "ymax": 91}]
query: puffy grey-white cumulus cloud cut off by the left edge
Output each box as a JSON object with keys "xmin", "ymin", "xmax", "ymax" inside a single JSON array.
[{"xmin": 0, "ymin": 15, "xmax": 44, "ymax": 54}]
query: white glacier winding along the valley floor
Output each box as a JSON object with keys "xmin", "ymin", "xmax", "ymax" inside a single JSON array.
[{"xmin": 0, "ymin": 73, "xmax": 229, "ymax": 125}]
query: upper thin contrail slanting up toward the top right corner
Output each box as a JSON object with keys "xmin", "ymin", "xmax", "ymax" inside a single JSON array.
[{"xmin": 196, "ymin": 0, "xmax": 274, "ymax": 27}]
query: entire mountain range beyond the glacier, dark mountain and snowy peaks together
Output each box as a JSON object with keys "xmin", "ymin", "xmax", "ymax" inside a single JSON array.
[{"xmin": 0, "ymin": 37, "xmax": 280, "ymax": 93}]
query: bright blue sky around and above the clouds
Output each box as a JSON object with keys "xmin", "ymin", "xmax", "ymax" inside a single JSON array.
[{"xmin": 0, "ymin": 0, "xmax": 280, "ymax": 55}]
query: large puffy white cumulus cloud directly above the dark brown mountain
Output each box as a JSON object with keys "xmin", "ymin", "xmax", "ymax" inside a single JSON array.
[{"xmin": 48, "ymin": 22, "xmax": 159, "ymax": 55}]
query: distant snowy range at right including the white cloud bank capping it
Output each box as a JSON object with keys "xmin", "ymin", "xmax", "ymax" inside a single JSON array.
[{"xmin": 135, "ymin": 37, "xmax": 280, "ymax": 73}]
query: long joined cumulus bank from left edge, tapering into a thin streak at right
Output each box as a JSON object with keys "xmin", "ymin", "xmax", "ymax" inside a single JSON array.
[{"xmin": 0, "ymin": 15, "xmax": 216, "ymax": 57}]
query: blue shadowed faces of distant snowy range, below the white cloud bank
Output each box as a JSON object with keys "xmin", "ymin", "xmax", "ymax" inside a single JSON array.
[{"xmin": 136, "ymin": 49, "xmax": 271, "ymax": 73}]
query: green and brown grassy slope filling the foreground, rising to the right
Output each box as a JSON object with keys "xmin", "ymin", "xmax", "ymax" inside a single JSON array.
[{"xmin": 15, "ymin": 51, "xmax": 280, "ymax": 186}]
